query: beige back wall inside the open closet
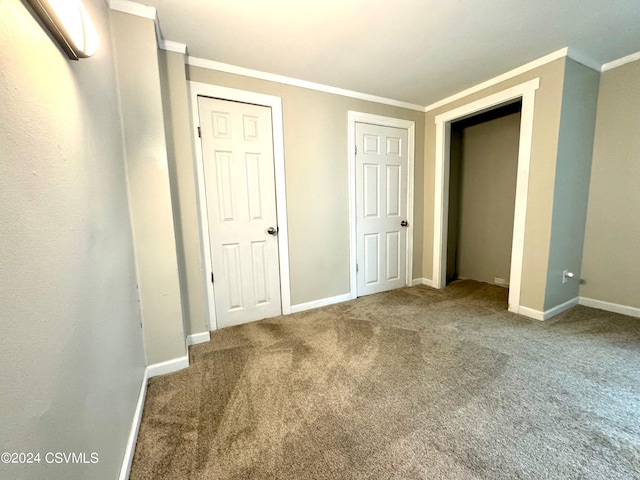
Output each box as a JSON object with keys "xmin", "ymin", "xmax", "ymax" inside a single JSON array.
[{"xmin": 451, "ymin": 113, "xmax": 520, "ymax": 283}]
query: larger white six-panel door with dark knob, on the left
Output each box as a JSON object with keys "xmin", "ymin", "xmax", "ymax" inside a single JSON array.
[{"xmin": 198, "ymin": 97, "xmax": 282, "ymax": 327}]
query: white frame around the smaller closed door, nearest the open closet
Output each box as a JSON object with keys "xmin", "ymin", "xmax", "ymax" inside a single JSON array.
[{"xmin": 347, "ymin": 110, "xmax": 416, "ymax": 298}]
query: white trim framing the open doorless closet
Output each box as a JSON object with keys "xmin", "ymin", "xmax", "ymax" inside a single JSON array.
[{"xmin": 433, "ymin": 78, "xmax": 540, "ymax": 313}]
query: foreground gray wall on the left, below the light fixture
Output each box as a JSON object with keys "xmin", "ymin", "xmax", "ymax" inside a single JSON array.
[{"xmin": 0, "ymin": 0, "xmax": 145, "ymax": 480}]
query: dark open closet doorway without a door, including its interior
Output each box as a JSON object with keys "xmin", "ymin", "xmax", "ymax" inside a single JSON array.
[{"xmin": 446, "ymin": 99, "xmax": 522, "ymax": 287}]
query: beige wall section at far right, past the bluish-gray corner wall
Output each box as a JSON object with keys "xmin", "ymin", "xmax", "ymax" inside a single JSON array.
[{"xmin": 580, "ymin": 61, "xmax": 640, "ymax": 308}]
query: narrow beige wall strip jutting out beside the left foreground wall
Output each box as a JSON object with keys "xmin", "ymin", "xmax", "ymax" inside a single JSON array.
[{"xmin": 111, "ymin": 11, "xmax": 186, "ymax": 364}]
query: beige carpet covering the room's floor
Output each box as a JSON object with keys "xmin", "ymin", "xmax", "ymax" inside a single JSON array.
[{"xmin": 130, "ymin": 281, "xmax": 640, "ymax": 480}]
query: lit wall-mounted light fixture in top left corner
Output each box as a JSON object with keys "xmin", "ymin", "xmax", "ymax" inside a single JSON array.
[{"xmin": 27, "ymin": 0, "xmax": 99, "ymax": 60}]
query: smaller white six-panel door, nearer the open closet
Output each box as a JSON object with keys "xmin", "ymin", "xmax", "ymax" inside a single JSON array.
[{"xmin": 356, "ymin": 122, "xmax": 408, "ymax": 296}]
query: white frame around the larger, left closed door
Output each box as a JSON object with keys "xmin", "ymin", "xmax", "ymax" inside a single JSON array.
[{"xmin": 188, "ymin": 81, "xmax": 291, "ymax": 330}]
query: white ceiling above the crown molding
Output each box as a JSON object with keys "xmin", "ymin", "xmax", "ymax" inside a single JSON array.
[{"xmin": 141, "ymin": 0, "xmax": 640, "ymax": 105}]
